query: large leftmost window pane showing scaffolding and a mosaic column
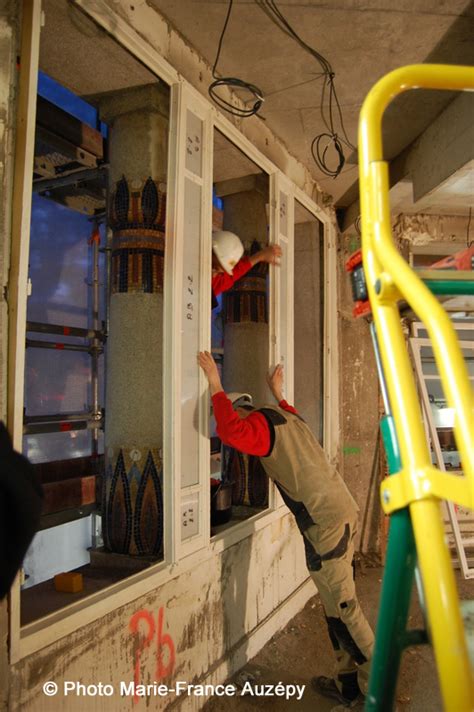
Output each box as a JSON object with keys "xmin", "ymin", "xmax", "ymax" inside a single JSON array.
[{"xmin": 21, "ymin": 0, "xmax": 172, "ymax": 622}]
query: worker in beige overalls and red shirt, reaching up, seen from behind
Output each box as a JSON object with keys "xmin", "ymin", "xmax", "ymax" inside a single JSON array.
[{"xmin": 198, "ymin": 351, "xmax": 374, "ymax": 707}]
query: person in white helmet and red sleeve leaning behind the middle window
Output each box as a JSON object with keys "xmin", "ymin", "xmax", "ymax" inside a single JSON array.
[{"xmin": 212, "ymin": 230, "xmax": 281, "ymax": 308}]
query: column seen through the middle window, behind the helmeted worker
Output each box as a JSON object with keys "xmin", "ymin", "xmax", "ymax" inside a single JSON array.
[{"xmin": 223, "ymin": 190, "xmax": 273, "ymax": 507}]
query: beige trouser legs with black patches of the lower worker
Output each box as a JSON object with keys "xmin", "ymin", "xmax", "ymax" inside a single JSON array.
[{"xmin": 305, "ymin": 522, "xmax": 374, "ymax": 694}]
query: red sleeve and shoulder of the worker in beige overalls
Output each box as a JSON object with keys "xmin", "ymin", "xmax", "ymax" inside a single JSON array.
[{"xmin": 212, "ymin": 391, "xmax": 270, "ymax": 457}]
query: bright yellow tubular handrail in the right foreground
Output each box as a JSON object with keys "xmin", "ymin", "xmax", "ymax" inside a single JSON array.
[{"xmin": 359, "ymin": 65, "xmax": 474, "ymax": 712}]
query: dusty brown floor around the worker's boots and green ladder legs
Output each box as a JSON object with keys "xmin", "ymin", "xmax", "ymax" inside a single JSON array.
[{"xmin": 204, "ymin": 564, "xmax": 474, "ymax": 712}]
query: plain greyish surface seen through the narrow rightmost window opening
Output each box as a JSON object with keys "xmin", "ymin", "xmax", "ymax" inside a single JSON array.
[{"xmin": 294, "ymin": 222, "xmax": 323, "ymax": 438}]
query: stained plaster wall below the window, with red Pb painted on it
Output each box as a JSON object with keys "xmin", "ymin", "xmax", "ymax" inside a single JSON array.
[{"xmin": 11, "ymin": 515, "xmax": 307, "ymax": 712}]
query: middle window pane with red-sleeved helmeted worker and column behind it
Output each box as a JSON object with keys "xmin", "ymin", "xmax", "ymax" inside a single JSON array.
[{"xmin": 210, "ymin": 130, "xmax": 271, "ymax": 533}]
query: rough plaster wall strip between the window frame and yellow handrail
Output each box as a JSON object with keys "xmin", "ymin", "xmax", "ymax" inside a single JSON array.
[{"xmin": 338, "ymin": 235, "xmax": 380, "ymax": 551}]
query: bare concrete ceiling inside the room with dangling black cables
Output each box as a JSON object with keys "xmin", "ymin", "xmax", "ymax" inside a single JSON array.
[{"xmin": 149, "ymin": 0, "xmax": 474, "ymax": 213}]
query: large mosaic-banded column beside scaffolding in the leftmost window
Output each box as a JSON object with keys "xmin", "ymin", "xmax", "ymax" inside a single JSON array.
[{"xmin": 101, "ymin": 83, "xmax": 169, "ymax": 557}]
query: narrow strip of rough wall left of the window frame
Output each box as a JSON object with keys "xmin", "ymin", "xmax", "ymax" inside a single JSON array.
[{"xmin": 0, "ymin": 0, "xmax": 18, "ymax": 710}]
